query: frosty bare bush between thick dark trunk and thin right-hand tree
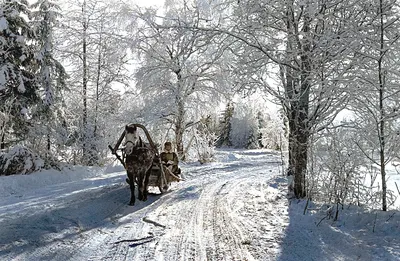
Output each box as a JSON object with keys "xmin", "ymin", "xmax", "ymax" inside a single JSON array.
[{"xmin": 310, "ymin": 129, "xmax": 366, "ymax": 205}]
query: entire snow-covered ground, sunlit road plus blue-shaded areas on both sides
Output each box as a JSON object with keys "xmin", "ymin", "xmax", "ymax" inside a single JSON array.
[{"xmin": 0, "ymin": 150, "xmax": 400, "ymax": 261}]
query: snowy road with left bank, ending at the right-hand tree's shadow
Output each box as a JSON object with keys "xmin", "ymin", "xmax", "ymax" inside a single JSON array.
[{"xmin": 0, "ymin": 151, "xmax": 288, "ymax": 260}]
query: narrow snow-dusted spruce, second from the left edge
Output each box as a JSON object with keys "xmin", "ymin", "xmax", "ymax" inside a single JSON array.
[{"xmin": 31, "ymin": 0, "xmax": 67, "ymax": 165}]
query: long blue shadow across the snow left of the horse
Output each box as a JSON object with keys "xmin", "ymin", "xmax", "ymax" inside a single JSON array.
[{"xmin": 0, "ymin": 176, "xmax": 161, "ymax": 259}]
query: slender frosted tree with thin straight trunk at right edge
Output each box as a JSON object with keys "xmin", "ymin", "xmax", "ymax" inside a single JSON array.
[{"xmin": 352, "ymin": 0, "xmax": 400, "ymax": 211}]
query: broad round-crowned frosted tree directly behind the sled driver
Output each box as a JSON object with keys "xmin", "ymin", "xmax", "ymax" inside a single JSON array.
[{"xmin": 132, "ymin": 1, "xmax": 227, "ymax": 157}]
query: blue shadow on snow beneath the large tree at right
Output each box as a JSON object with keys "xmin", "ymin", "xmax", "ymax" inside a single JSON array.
[{"xmin": 277, "ymin": 197, "xmax": 400, "ymax": 261}]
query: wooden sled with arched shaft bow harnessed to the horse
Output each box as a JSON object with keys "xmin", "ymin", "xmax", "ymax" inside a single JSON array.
[{"xmin": 108, "ymin": 123, "xmax": 181, "ymax": 193}]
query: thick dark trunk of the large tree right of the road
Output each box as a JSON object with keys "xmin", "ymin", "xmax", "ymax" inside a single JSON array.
[{"xmin": 285, "ymin": 0, "xmax": 311, "ymax": 198}]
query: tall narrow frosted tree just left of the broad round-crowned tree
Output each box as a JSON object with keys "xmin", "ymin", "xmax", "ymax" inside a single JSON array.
[{"xmin": 91, "ymin": 3, "xmax": 132, "ymax": 162}]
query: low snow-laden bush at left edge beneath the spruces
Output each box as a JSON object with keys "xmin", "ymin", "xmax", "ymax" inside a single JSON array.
[{"xmin": 0, "ymin": 146, "xmax": 44, "ymax": 176}]
